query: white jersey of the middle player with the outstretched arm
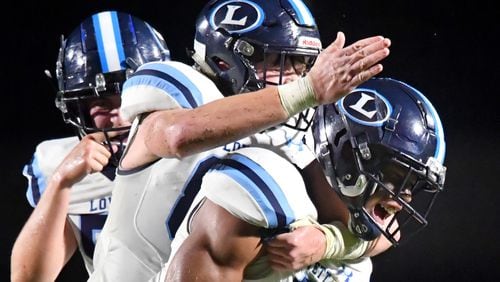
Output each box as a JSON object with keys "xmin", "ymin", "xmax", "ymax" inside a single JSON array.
[{"xmin": 90, "ymin": 62, "xmax": 314, "ymax": 281}]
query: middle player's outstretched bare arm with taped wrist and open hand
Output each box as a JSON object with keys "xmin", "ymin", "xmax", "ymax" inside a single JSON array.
[{"xmin": 142, "ymin": 32, "xmax": 391, "ymax": 158}]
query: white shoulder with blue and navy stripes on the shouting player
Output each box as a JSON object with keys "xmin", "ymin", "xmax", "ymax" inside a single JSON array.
[{"xmin": 201, "ymin": 147, "xmax": 317, "ymax": 229}]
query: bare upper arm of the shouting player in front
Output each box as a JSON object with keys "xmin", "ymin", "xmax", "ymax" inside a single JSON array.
[{"xmin": 167, "ymin": 200, "xmax": 262, "ymax": 281}]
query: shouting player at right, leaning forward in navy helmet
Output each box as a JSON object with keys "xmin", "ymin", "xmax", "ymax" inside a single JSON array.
[{"xmin": 166, "ymin": 79, "xmax": 446, "ymax": 281}]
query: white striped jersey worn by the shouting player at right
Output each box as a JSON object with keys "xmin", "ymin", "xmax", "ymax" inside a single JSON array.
[{"xmin": 166, "ymin": 148, "xmax": 372, "ymax": 282}]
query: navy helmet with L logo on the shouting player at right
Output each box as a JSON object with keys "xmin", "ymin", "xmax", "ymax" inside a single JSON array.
[{"xmin": 312, "ymin": 78, "xmax": 446, "ymax": 245}]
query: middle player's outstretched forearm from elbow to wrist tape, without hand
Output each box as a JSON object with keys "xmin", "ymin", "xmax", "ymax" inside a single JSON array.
[{"xmin": 141, "ymin": 87, "xmax": 288, "ymax": 157}]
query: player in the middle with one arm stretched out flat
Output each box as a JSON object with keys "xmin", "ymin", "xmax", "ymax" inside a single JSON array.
[{"xmin": 90, "ymin": 1, "xmax": 390, "ymax": 281}]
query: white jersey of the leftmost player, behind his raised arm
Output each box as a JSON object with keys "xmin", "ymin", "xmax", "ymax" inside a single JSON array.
[{"xmin": 23, "ymin": 137, "xmax": 115, "ymax": 273}]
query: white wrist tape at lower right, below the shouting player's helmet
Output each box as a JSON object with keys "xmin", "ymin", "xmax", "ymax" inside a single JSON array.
[{"xmin": 290, "ymin": 218, "xmax": 370, "ymax": 260}]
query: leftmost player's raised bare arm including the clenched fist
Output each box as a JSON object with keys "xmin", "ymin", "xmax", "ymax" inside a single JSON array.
[{"xmin": 11, "ymin": 133, "xmax": 111, "ymax": 281}]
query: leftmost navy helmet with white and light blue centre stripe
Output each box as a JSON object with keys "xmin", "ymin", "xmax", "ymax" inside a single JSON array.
[{"xmin": 55, "ymin": 11, "xmax": 170, "ymax": 143}]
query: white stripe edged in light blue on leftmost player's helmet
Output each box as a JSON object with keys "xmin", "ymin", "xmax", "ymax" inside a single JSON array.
[{"xmin": 92, "ymin": 12, "xmax": 125, "ymax": 73}]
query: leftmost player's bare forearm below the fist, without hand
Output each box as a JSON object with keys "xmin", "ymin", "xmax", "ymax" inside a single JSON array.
[{"xmin": 11, "ymin": 177, "xmax": 76, "ymax": 281}]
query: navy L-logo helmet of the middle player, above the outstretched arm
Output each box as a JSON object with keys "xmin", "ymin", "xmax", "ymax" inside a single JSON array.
[{"xmin": 192, "ymin": 0, "xmax": 321, "ymax": 130}]
